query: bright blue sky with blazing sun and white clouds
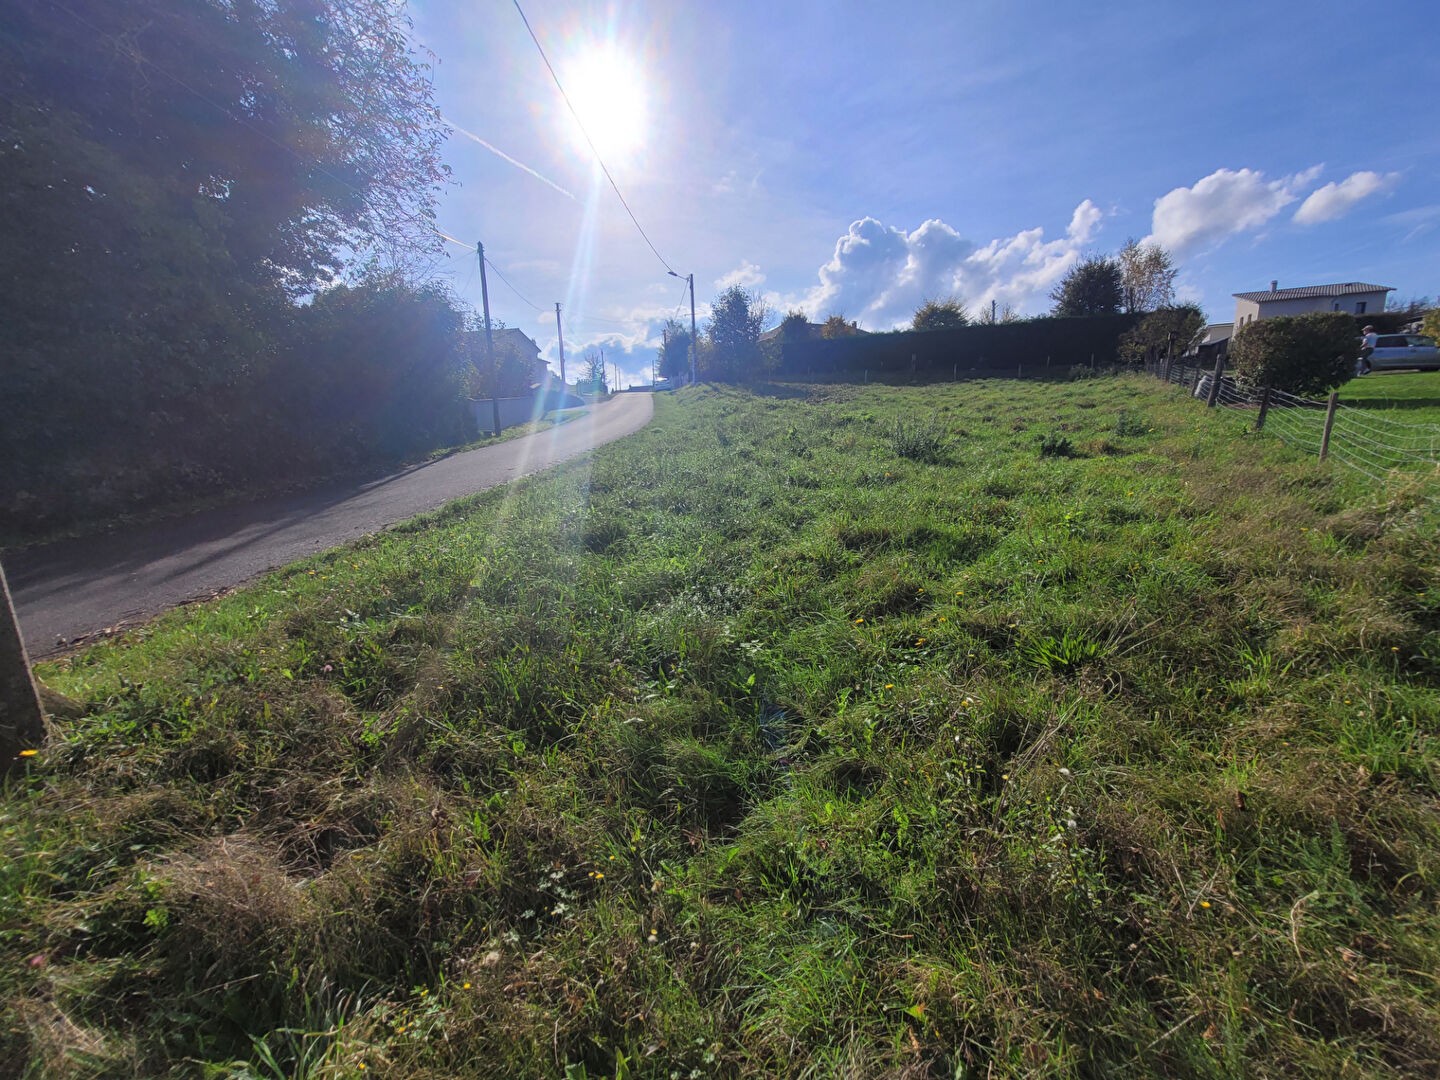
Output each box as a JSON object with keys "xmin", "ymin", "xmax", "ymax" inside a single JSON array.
[{"xmin": 410, "ymin": 0, "xmax": 1440, "ymax": 380}]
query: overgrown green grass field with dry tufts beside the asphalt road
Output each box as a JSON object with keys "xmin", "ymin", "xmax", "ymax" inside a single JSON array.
[{"xmin": 0, "ymin": 376, "xmax": 1440, "ymax": 1079}]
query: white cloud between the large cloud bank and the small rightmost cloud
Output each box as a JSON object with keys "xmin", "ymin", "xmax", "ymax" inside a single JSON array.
[{"xmin": 1146, "ymin": 166, "xmax": 1320, "ymax": 255}]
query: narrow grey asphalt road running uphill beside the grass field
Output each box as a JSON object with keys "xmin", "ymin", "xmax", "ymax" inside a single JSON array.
[{"xmin": 4, "ymin": 393, "xmax": 654, "ymax": 657}]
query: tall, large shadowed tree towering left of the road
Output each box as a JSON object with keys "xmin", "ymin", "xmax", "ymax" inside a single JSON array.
[{"xmin": 0, "ymin": 0, "xmax": 446, "ymax": 538}]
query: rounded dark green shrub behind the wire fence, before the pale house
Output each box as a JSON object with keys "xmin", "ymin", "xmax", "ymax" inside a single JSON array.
[{"xmin": 1230, "ymin": 311, "xmax": 1359, "ymax": 395}]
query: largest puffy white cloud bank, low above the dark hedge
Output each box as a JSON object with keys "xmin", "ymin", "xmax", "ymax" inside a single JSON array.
[{"xmin": 775, "ymin": 199, "xmax": 1104, "ymax": 330}]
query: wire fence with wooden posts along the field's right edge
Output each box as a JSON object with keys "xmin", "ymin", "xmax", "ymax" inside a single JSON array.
[{"xmin": 1145, "ymin": 357, "xmax": 1440, "ymax": 481}]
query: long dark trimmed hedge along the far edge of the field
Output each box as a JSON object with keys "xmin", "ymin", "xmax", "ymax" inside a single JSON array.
[{"xmin": 775, "ymin": 315, "xmax": 1140, "ymax": 379}]
